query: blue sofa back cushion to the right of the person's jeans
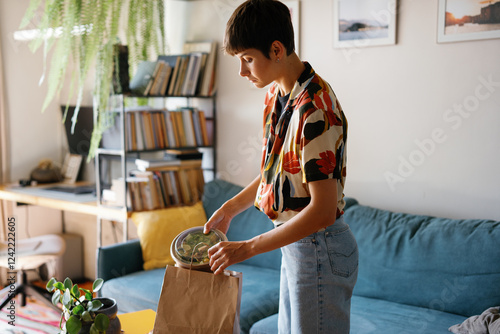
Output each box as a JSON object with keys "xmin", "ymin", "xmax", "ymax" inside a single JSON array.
[{"xmin": 344, "ymin": 205, "xmax": 500, "ymax": 316}]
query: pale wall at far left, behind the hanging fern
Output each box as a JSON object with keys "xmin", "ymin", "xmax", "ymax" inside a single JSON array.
[{"xmin": 0, "ymin": 0, "xmax": 63, "ymax": 181}]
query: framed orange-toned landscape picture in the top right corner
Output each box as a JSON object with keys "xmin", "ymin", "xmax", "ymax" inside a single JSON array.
[{"xmin": 437, "ymin": 0, "xmax": 500, "ymax": 43}]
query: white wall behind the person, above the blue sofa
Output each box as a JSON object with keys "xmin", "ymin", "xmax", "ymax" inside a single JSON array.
[{"xmin": 174, "ymin": 0, "xmax": 500, "ymax": 219}]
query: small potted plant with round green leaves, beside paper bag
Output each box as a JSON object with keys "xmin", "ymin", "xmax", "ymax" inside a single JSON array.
[{"xmin": 46, "ymin": 278, "xmax": 121, "ymax": 334}]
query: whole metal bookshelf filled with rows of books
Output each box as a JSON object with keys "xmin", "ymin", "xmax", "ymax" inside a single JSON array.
[{"xmin": 95, "ymin": 42, "xmax": 217, "ymax": 240}]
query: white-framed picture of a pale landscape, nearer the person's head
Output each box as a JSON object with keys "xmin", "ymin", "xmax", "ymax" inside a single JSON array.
[{"xmin": 333, "ymin": 0, "xmax": 397, "ymax": 48}]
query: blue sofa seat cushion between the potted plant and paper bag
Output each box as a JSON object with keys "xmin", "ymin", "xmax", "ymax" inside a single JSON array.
[{"xmin": 101, "ymin": 268, "xmax": 165, "ymax": 313}]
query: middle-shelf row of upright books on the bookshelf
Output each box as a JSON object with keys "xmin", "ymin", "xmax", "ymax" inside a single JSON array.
[{"xmin": 125, "ymin": 108, "xmax": 213, "ymax": 151}]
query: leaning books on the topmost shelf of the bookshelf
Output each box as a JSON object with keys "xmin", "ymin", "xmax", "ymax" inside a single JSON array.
[{"xmin": 130, "ymin": 42, "xmax": 217, "ymax": 96}]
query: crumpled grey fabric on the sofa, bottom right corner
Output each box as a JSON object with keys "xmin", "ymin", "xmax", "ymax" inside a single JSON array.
[{"xmin": 448, "ymin": 306, "xmax": 500, "ymax": 334}]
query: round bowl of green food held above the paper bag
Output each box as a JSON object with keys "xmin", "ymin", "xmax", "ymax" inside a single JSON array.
[{"xmin": 172, "ymin": 226, "xmax": 227, "ymax": 266}]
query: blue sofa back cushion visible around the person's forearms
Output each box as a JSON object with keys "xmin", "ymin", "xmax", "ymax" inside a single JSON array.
[{"xmin": 203, "ymin": 180, "xmax": 281, "ymax": 270}]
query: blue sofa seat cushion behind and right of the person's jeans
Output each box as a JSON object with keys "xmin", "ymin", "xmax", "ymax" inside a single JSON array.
[{"xmin": 250, "ymin": 296, "xmax": 466, "ymax": 334}]
